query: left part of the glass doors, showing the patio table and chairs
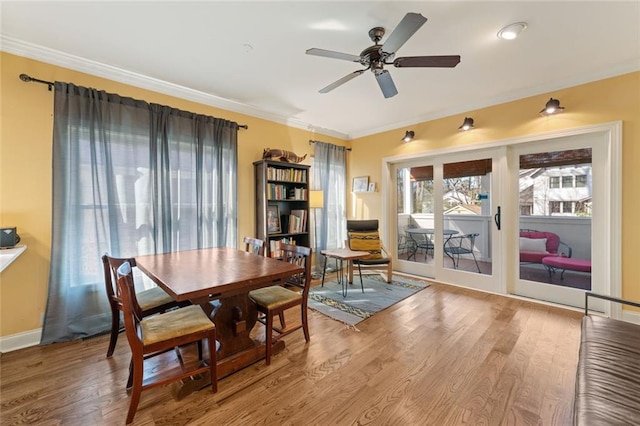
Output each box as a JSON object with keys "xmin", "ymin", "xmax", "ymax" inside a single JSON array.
[{"xmin": 394, "ymin": 148, "xmax": 504, "ymax": 292}]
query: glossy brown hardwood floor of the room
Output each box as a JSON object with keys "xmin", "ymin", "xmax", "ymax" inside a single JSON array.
[{"xmin": 0, "ymin": 274, "xmax": 582, "ymax": 426}]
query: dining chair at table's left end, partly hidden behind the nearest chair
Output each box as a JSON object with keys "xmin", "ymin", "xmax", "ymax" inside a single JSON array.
[{"xmin": 102, "ymin": 254, "xmax": 185, "ymax": 358}]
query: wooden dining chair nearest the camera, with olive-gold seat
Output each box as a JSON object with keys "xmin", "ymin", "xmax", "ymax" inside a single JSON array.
[{"xmin": 116, "ymin": 262, "xmax": 218, "ymax": 424}]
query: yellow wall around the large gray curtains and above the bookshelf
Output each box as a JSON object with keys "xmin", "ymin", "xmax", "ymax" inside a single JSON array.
[{"xmin": 0, "ymin": 53, "xmax": 348, "ymax": 337}]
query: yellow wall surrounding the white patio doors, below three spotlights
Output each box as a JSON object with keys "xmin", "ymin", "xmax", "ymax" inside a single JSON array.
[{"xmin": 348, "ymin": 72, "xmax": 640, "ymax": 301}]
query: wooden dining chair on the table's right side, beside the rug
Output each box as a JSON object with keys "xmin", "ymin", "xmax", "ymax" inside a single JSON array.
[{"xmin": 249, "ymin": 244, "xmax": 311, "ymax": 365}]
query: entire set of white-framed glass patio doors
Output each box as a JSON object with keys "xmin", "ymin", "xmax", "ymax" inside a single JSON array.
[{"xmin": 383, "ymin": 123, "xmax": 621, "ymax": 317}]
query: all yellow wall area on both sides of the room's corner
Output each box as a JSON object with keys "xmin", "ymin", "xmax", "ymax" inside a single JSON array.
[{"xmin": 0, "ymin": 53, "xmax": 640, "ymax": 337}]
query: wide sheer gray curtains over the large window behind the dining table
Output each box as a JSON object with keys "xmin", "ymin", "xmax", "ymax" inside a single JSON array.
[{"xmin": 41, "ymin": 82, "xmax": 238, "ymax": 344}]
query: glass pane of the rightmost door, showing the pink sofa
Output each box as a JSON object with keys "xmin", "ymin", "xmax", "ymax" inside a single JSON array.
[{"xmin": 519, "ymin": 148, "xmax": 593, "ymax": 290}]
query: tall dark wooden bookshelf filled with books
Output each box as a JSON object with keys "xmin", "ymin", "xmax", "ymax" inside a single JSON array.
[{"xmin": 253, "ymin": 160, "xmax": 310, "ymax": 257}]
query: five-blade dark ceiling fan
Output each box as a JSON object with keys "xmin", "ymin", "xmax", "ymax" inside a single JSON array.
[{"xmin": 306, "ymin": 13, "xmax": 460, "ymax": 98}]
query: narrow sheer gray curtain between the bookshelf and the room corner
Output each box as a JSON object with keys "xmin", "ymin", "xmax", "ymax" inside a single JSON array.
[{"xmin": 313, "ymin": 141, "xmax": 347, "ymax": 265}]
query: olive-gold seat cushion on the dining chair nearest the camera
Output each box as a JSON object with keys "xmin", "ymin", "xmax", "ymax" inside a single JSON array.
[{"xmin": 140, "ymin": 305, "xmax": 215, "ymax": 345}]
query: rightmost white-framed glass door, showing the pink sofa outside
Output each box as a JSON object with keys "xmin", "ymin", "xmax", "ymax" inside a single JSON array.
[{"xmin": 508, "ymin": 133, "xmax": 610, "ymax": 307}]
